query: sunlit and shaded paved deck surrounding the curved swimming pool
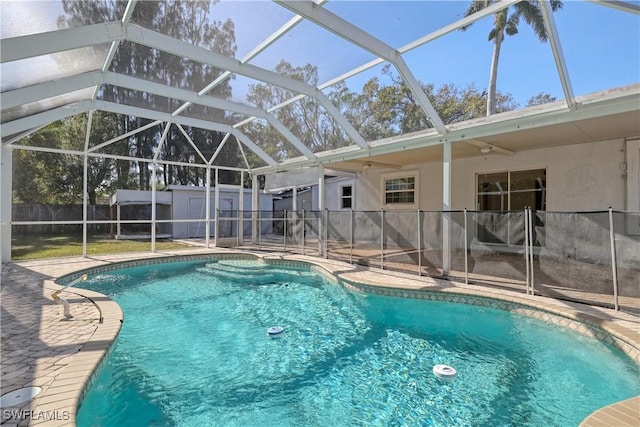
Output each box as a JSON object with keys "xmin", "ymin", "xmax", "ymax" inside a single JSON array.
[{"xmin": 0, "ymin": 248, "xmax": 640, "ymax": 427}]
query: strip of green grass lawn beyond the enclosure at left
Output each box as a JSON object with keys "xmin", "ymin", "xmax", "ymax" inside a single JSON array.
[{"xmin": 11, "ymin": 235, "xmax": 189, "ymax": 261}]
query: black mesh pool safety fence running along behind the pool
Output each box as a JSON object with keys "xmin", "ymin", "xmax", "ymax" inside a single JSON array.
[{"xmin": 12, "ymin": 209, "xmax": 640, "ymax": 314}]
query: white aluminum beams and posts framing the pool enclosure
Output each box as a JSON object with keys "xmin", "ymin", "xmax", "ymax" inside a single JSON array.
[{"xmin": 0, "ymin": 0, "xmax": 640, "ymax": 262}]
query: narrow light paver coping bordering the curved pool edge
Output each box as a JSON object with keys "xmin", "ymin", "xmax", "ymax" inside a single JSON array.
[{"xmin": 3, "ymin": 249, "xmax": 640, "ymax": 426}]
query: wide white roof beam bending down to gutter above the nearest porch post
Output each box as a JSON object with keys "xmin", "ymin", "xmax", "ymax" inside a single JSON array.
[{"xmin": 274, "ymin": 0, "xmax": 447, "ymax": 134}]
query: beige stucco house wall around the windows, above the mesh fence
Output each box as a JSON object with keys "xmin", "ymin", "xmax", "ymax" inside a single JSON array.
[{"xmin": 352, "ymin": 139, "xmax": 640, "ymax": 212}]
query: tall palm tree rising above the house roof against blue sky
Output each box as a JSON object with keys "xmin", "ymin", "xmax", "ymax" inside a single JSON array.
[{"xmin": 462, "ymin": 0, "xmax": 562, "ymax": 116}]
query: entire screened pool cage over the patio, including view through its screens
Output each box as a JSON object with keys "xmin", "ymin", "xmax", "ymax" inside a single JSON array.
[{"xmin": 0, "ymin": 0, "xmax": 640, "ymax": 310}]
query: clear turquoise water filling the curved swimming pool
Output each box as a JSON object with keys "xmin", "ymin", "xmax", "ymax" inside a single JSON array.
[{"xmin": 77, "ymin": 261, "xmax": 640, "ymax": 427}]
